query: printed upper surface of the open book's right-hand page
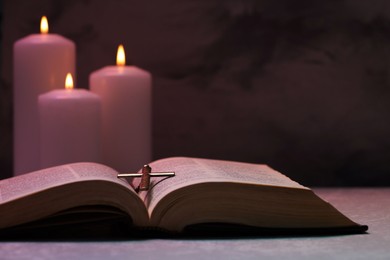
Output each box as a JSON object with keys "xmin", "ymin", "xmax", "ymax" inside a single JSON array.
[{"xmin": 140, "ymin": 157, "xmax": 307, "ymax": 214}]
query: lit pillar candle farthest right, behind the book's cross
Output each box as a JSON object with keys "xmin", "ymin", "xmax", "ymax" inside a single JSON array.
[{"xmin": 89, "ymin": 45, "xmax": 152, "ymax": 172}]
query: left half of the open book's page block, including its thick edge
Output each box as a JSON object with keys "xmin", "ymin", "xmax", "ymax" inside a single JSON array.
[{"xmin": 0, "ymin": 163, "xmax": 149, "ymax": 229}]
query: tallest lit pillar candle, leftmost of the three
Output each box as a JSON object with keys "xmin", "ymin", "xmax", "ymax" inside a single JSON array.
[{"xmin": 13, "ymin": 17, "xmax": 75, "ymax": 175}]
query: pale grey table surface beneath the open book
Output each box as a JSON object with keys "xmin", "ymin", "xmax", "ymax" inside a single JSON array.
[{"xmin": 0, "ymin": 187, "xmax": 390, "ymax": 260}]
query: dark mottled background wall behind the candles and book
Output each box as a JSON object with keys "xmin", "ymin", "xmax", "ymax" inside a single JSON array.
[{"xmin": 0, "ymin": 0, "xmax": 390, "ymax": 185}]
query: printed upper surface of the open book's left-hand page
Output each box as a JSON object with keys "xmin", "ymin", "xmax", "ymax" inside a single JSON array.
[{"xmin": 0, "ymin": 163, "xmax": 130, "ymax": 204}]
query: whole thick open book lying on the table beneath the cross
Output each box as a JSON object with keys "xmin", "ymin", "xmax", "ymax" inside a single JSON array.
[{"xmin": 0, "ymin": 157, "xmax": 367, "ymax": 238}]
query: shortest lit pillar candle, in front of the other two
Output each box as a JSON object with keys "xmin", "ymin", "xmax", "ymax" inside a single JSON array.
[{"xmin": 38, "ymin": 74, "xmax": 101, "ymax": 168}]
